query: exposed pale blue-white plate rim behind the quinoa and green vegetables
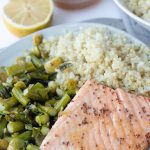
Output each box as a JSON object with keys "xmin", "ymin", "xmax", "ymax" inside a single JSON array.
[{"xmin": 0, "ymin": 23, "xmax": 146, "ymax": 66}]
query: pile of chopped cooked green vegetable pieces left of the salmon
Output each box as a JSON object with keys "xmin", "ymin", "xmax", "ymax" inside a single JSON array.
[{"xmin": 0, "ymin": 35, "xmax": 76, "ymax": 150}]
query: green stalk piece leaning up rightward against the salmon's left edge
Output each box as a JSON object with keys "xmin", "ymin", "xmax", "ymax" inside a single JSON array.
[{"xmin": 54, "ymin": 94, "xmax": 71, "ymax": 113}]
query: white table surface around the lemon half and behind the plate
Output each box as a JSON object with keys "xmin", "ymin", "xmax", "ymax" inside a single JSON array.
[{"xmin": 0, "ymin": 0, "xmax": 121, "ymax": 48}]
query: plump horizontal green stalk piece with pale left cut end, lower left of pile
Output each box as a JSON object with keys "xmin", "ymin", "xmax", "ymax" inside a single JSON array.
[{"xmin": 7, "ymin": 121, "xmax": 25, "ymax": 133}]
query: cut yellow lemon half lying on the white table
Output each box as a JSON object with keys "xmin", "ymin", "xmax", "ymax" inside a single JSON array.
[{"xmin": 3, "ymin": 0, "xmax": 53, "ymax": 37}]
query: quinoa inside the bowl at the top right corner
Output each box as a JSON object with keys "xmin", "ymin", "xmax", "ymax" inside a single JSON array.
[{"xmin": 123, "ymin": 0, "xmax": 150, "ymax": 22}]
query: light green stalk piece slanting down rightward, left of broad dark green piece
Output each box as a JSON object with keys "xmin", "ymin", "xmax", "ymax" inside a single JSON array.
[{"xmin": 12, "ymin": 87, "xmax": 30, "ymax": 106}]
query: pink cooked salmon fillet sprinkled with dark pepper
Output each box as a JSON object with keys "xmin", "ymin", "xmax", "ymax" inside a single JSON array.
[{"xmin": 41, "ymin": 80, "xmax": 150, "ymax": 150}]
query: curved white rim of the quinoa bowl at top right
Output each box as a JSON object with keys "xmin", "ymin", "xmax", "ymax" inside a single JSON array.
[{"xmin": 113, "ymin": 0, "xmax": 150, "ymax": 27}]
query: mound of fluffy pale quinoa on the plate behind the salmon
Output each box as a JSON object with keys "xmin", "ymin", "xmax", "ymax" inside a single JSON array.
[{"xmin": 40, "ymin": 27, "xmax": 150, "ymax": 96}]
